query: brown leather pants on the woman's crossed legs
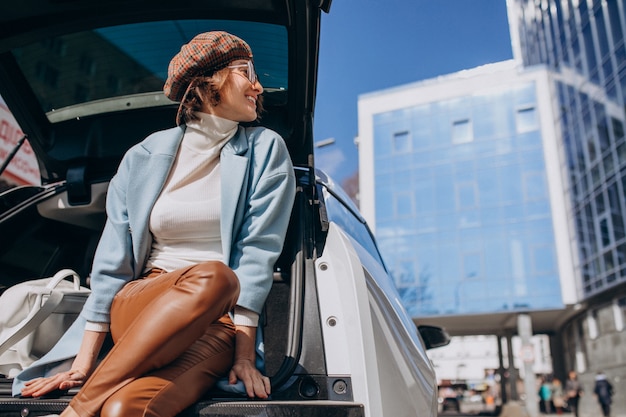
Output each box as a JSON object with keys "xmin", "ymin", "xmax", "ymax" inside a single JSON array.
[{"xmin": 69, "ymin": 262, "xmax": 239, "ymax": 417}]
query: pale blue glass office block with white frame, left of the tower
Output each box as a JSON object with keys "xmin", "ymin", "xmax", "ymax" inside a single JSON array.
[{"xmin": 359, "ymin": 61, "xmax": 574, "ymax": 317}]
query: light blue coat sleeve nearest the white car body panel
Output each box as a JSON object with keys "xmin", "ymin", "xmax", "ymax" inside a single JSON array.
[{"xmin": 230, "ymin": 129, "xmax": 295, "ymax": 313}]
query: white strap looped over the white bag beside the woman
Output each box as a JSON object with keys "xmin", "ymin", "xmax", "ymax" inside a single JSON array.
[{"xmin": 0, "ymin": 269, "xmax": 80, "ymax": 355}]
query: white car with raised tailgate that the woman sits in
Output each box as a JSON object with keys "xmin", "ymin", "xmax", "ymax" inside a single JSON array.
[{"xmin": 0, "ymin": 0, "xmax": 449, "ymax": 417}]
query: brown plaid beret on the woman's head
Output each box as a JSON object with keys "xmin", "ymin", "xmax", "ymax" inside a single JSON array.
[{"xmin": 163, "ymin": 31, "xmax": 252, "ymax": 101}]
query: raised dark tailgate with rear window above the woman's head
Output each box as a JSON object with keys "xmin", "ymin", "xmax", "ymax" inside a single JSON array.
[{"xmin": 0, "ymin": 0, "xmax": 330, "ymax": 185}]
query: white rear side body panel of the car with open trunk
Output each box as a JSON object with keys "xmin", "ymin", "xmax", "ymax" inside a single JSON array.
[{"xmin": 316, "ymin": 221, "xmax": 437, "ymax": 416}]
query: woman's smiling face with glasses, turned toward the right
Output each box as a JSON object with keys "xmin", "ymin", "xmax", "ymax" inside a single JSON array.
[{"xmin": 203, "ymin": 59, "xmax": 263, "ymax": 122}]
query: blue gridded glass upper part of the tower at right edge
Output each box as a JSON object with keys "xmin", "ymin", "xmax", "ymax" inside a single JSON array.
[{"xmin": 508, "ymin": 0, "xmax": 626, "ymax": 298}]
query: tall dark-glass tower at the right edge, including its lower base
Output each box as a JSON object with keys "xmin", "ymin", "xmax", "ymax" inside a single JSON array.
[{"xmin": 507, "ymin": 0, "xmax": 626, "ymax": 412}]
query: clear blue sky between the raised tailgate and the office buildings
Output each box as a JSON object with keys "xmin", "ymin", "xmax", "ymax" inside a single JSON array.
[{"xmin": 314, "ymin": 0, "xmax": 513, "ymax": 183}]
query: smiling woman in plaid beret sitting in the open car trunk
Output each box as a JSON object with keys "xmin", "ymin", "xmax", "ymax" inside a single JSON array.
[{"xmin": 14, "ymin": 32, "xmax": 295, "ymax": 417}]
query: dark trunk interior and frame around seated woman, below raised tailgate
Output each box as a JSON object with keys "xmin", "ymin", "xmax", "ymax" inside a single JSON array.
[{"xmin": 0, "ymin": 169, "xmax": 360, "ymax": 417}]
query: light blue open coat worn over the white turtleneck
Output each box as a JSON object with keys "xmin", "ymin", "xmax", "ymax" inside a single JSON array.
[{"xmin": 13, "ymin": 122, "xmax": 295, "ymax": 395}]
